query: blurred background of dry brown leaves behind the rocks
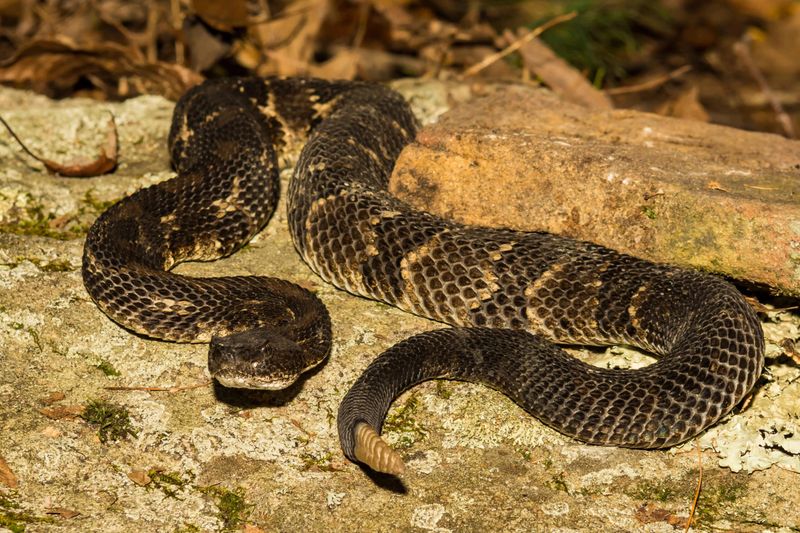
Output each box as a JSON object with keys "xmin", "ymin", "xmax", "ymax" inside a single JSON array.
[{"xmin": 0, "ymin": 0, "xmax": 800, "ymax": 138}]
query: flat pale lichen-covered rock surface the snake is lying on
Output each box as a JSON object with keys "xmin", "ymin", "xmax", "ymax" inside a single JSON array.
[{"xmin": 0, "ymin": 83, "xmax": 800, "ymax": 532}]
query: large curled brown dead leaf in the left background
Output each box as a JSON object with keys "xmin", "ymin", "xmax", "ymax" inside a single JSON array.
[{"xmin": 0, "ymin": 38, "xmax": 203, "ymax": 100}]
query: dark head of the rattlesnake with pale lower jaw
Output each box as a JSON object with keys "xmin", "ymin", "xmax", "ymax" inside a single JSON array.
[{"xmin": 208, "ymin": 328, "xmax": 314, "ymax": 390}]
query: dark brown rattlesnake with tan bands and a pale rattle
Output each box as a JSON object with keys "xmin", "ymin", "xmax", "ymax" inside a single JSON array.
[{"xmin": 82, "ymin": 77, "xmax": 764, "ymax": 475}]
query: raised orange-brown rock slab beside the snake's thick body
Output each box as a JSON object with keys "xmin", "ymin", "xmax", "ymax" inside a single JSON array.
[{"xmin": 392, "ymin": 86, "xmax": 800, "ymax": 296}]
